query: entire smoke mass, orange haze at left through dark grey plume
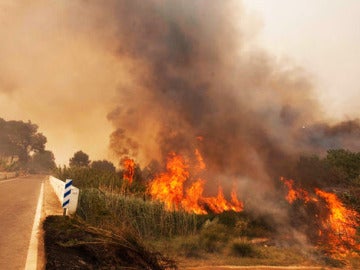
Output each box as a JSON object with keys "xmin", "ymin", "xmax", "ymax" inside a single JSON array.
[{"xmin": 0, "ymin": 0, "xmax": 360, "ymax": 228}]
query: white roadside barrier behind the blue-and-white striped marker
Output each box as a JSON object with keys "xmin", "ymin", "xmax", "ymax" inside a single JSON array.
[{"xmin": 49, "ymin": 176, "xmax": 79, "ymax": 215}]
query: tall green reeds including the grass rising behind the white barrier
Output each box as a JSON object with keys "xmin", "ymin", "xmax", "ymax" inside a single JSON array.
[{"xmin": 54, "ymin": 167, "xmax": 198, "ymax": 238}]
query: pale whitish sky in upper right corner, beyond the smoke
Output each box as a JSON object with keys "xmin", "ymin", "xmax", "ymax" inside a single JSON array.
[{"xmin": 243, "ymin": 0, "xmax": 360, "ymax": 118}]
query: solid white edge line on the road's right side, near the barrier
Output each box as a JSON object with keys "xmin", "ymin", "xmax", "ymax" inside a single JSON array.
[{"xmin": 25, "ymin": 181, "xmax": 44, "ymax": 270}]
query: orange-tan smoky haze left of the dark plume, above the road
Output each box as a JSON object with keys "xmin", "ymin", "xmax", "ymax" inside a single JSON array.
[{"xmin": 0, "ymin": 0, "xmax": 122, "ymax": 164}]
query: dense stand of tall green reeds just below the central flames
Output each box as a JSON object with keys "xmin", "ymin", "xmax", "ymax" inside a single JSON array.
[{"xmin": 77, "ymin": 188, "xmax": 198, "ymax": 238}]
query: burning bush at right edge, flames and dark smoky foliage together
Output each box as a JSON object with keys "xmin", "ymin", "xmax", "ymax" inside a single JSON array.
[{"xmin": 281, "ymin": 178, "xmax": 360, "ymax": 257}]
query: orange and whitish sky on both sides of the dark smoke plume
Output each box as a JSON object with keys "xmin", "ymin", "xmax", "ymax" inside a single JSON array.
[{"xmin": 0, "ymin": 0, "xmax": 360, "ymax": 164}]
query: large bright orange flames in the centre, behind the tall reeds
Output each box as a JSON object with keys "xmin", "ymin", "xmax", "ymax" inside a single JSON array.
[{"xmin": 149, "ymin": 149, "xmax": 243, "ymax": 214}]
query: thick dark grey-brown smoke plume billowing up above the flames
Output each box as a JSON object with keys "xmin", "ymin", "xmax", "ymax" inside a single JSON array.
[{"xmin": 95, "ymin": 0, "xmax": 360, "ymax": 189}]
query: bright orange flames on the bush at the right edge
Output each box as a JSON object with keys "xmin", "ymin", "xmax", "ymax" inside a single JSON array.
[{"xmin": 280, "ymin": 178, "xmax": 360, "ymax": 257}]
